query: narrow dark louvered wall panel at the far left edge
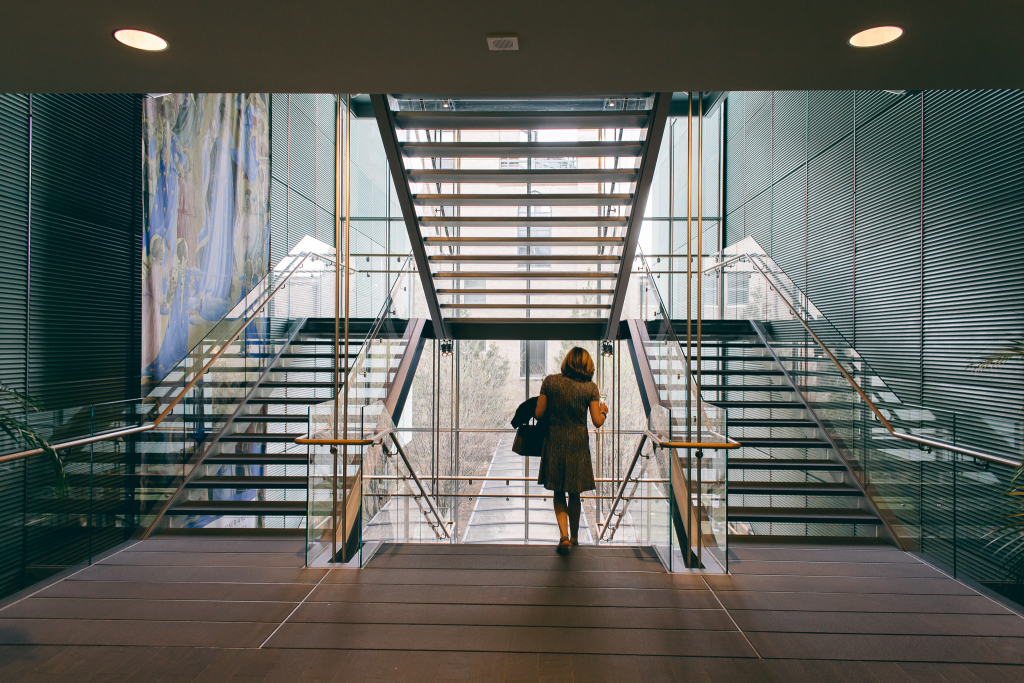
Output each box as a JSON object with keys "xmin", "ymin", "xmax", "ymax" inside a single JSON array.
[{"xmin": 0, "ymin": 95, "xmax": 29, "ymax": 595}]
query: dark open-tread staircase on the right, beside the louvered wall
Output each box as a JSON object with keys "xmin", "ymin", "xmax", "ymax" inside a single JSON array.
[{"xmin": 648, "ymin": 321, "xmax": 888, "ymax": 543}]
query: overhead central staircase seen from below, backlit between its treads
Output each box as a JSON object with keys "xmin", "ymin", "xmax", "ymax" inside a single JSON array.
[{"xmin": 371, "ymin": 93, "xmax": 671, "ymax": 339}]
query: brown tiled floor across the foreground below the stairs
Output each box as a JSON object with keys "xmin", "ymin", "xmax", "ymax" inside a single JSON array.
[{"xmin": 0, "ymin": 538, "xmax": 1024, "ymax": 683}]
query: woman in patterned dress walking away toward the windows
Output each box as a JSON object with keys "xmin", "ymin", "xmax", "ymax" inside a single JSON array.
[{"xmin": 536, "ymin": 346, "xmax": 608, "ymax": 555}]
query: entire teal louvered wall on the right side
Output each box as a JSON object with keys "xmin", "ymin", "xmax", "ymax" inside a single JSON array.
[{"xmin": 725, "ymin": 91, "xmax": 1024, "ymax": 582}]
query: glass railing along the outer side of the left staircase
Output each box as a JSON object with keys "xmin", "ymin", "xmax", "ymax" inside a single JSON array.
[{"xmin": 0, "ymin": 252, "xmax": 344, "ymax": 593}]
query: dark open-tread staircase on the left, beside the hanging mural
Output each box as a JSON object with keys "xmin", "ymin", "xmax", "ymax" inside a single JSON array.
[{"xmin": 150, "ymin": 318, "xmax": 406, "ymax": 535}]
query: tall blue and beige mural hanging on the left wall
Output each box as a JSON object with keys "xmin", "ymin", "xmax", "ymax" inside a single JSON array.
[{"xmin": 142, "ymin": 93, "xmax": 270, "ymax": 383}]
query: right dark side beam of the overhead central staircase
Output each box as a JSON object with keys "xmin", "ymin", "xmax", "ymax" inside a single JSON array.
[{"xmin": 604, "ymin": 92, "xmax": 672, "ymax": 339}]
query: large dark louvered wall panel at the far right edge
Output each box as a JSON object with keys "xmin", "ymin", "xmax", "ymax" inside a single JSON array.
[{"xmin": 925, "ymin": 91, "xmax": 1024, "ymax": 420}]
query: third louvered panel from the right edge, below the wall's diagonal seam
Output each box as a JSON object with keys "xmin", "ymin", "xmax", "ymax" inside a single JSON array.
[{"xmin": 807, "ymin": 136, "xmax": 855, "ymax": 343}]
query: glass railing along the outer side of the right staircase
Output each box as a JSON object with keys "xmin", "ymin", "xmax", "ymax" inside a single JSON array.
[{"xmin": 709, "ymin": 239, "xmax": 1024, "ymax": 590}]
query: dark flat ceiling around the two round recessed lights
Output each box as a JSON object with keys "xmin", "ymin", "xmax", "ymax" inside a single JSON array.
[{"xmin": 0, "ymin": 0, "xmax": 1024, "ymax": 93}]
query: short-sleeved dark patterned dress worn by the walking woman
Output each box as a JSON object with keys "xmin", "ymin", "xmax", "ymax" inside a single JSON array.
[{"xmin": 537, "ymin": 374, "xmax": 601, "ymax": 494}]
